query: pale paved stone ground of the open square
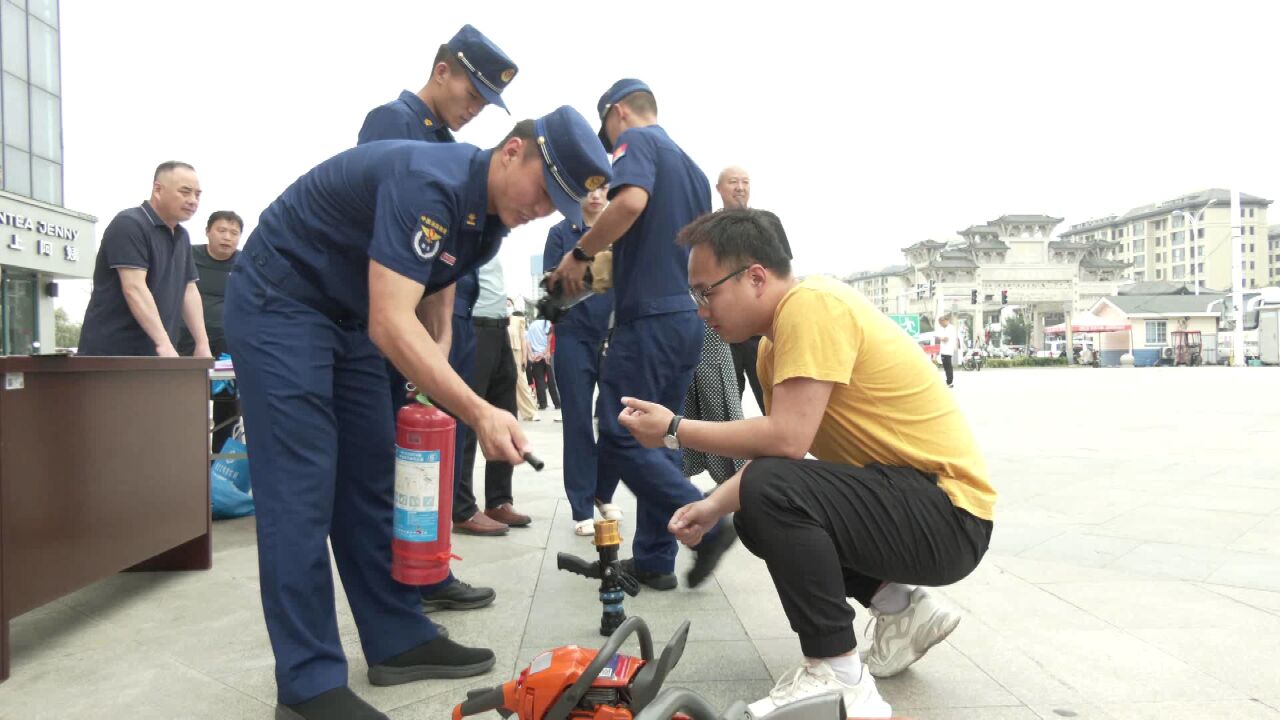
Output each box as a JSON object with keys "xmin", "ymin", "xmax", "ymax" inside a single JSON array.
[{"xmin": 0, "ymin": 368, "xmax": 1280, "ymax": 720}]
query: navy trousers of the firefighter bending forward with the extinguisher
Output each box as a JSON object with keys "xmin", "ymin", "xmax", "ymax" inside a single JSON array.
[{"xmin": 225, "ymin": 258, "xmax": 436, "ymax": 703}]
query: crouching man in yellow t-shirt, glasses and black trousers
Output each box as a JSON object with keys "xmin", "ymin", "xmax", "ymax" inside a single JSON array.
[{"xmin": 620, "ymin": 209, "xmax": 996, "ymax": 717}]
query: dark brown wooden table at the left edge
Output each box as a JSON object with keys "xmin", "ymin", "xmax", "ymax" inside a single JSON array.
[{"xmin": 0, "ymin": 356, "xmax": 212, "ymax": 680}]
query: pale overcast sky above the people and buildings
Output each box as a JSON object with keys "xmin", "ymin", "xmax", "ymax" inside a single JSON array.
[{"xmin": 52, "ymin": 0, "xmax": 1280, "ymax": 316}]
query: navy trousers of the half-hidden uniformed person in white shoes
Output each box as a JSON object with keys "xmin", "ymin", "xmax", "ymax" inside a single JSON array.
[{"xmin": 552, "ymin": 325, "xmax": 618, "ymax": 523}]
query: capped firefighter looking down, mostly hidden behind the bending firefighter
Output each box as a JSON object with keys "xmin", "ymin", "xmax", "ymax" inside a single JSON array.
[{"xmin": 358, "ymin": 24, "xmax": 518, "ymax": 611}]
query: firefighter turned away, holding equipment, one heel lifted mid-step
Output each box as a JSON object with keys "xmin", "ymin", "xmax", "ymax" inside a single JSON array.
[{"xmin": 556, "ymin": 79, "xmax": 735, "ymax": 589}]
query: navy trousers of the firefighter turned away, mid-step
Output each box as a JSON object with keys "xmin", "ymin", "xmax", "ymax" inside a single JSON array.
[{"xmin": 596, "ymin": 310, "xmax": 718, "ymax": 573}]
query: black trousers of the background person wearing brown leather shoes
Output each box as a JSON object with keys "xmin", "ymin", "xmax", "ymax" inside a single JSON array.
[{"xmin": 453, "ymin": 318, "xmax": 517, "ymax": 523}]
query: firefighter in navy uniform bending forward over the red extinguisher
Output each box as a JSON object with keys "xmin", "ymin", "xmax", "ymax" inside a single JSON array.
[{"xmin": 227, "ymin": 106, "xmax": 609, "ymax": 720}]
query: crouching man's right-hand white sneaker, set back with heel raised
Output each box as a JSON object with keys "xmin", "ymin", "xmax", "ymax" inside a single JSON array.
[{"xmin": 867, "ymin": 588, "xmax": 960, "ymax": 678}]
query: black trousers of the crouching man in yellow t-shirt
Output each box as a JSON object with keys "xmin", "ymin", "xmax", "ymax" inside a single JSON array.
[{"xmin": 733, "ymin": 457, "xmax": 992, "ymax": 657}]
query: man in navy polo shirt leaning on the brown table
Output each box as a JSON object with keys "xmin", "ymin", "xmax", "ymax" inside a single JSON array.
[{"xmin": 78, "ymin": 161, "xmax": 211, "ymax": 357}]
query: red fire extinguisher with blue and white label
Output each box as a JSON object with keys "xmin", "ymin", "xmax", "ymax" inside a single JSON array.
[{"xmin": 392, "ymin": 395, "xmax": 461, "ymax": 585}]
